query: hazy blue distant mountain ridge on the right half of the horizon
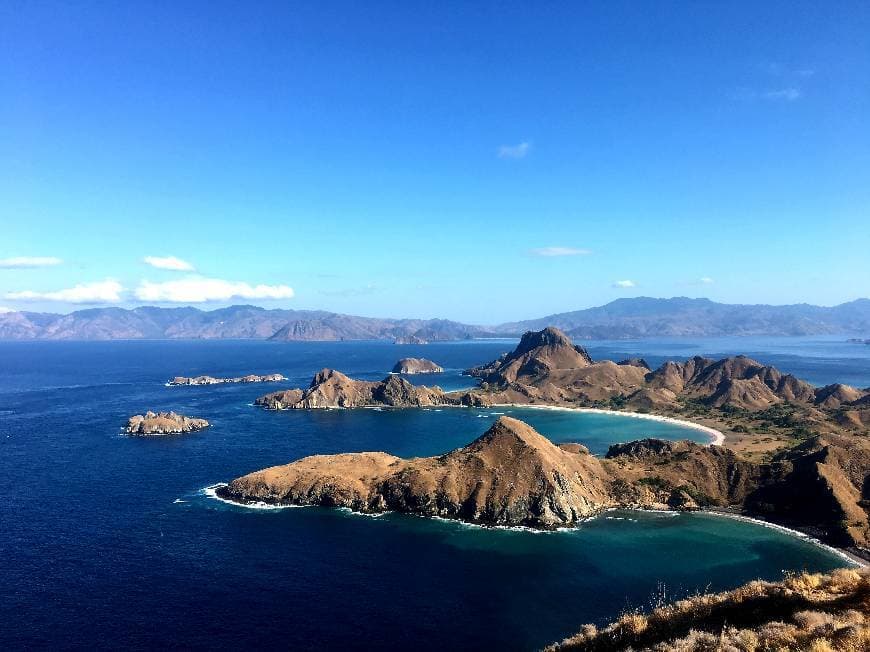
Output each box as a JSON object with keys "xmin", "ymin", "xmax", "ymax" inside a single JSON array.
[{"xmin": 496, "ymin": 297, "xmax": 870, "ymax": 339}]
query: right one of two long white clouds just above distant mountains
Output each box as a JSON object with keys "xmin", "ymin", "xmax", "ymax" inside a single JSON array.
[{"xmin": 136, "ymin": 276, "xmax": 293, "ymax": 303}]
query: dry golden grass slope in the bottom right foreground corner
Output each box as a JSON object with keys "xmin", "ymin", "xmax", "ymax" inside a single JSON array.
[{"xmin": 548, "ymin": 568, "xmax": 870, "ymax": 652}]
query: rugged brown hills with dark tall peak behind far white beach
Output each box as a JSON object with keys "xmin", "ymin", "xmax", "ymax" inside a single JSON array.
[{"xmin": 466, "ymin": 326, "xmax": 870, "ymax": 420}]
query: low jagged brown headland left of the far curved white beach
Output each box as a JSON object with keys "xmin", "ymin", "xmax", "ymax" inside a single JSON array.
[{"xmin": 254, "ymin": 369, "xmax": 464, "ymax": 410}]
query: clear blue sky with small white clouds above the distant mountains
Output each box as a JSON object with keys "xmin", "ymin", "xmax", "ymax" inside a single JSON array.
[{"xmin": 0, "ymin": 1, "xmax": 870, "ymax": 323}]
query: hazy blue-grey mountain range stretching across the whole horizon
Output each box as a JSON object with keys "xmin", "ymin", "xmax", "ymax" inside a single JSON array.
[{"xmin": 0, "ymin": 297, "xmax": 870, "ymax": 342}]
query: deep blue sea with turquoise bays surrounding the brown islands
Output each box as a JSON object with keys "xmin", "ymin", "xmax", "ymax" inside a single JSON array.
[{"xmin": 0, "ymin": 338, "xmax": 870, "ymax": 650}]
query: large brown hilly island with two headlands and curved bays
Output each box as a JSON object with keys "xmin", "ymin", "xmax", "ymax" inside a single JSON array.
[{"xmin": 242, "ymin": 328, "xmax": 870, "ymax": 556}]
